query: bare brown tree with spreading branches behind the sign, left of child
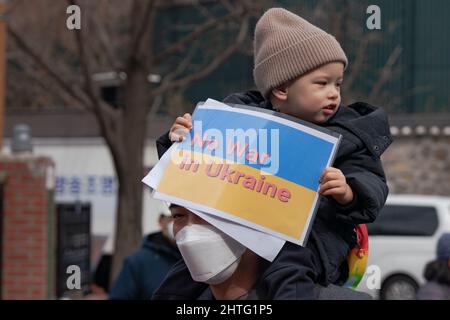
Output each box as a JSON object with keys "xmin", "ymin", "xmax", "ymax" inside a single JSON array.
[{"xmin": 4, "ymin": 0, "xmax": 261, "ymax": 278}]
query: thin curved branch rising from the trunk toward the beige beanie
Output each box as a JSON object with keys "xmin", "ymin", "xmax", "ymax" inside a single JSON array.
[{"xmin": 151, "ymin": 17, "xmax": 249, "ymax": 98}]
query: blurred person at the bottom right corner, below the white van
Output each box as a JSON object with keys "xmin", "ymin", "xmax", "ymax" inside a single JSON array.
[{"xmin": 417, "ymin": 233, "xmax": 450, "ymax": 300}]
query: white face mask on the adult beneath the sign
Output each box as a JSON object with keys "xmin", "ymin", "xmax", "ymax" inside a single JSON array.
[{"xmin": 175, "ymin": 224, "xmax": 246, "ymax": 284}]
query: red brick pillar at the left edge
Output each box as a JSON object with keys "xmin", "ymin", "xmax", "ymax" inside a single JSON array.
[{"xmin": 0, "ymin": 155, "xmax": 55, "ymax": 299}]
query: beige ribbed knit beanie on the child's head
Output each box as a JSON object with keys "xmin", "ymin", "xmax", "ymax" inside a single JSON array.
[{"xmin": 253, "ymin": 8, "xmax": 348, "ymax": 98}]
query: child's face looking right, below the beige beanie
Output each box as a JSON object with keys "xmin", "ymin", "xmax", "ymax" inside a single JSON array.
[{"xmin": 275, "ymin": 62, "xmax": 344, "ymax": 124}]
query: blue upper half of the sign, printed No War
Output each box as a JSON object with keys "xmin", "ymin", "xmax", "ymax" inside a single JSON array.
[{"xmin": 181, "ymin": 109, "xmax": 333, "ymax": 191}]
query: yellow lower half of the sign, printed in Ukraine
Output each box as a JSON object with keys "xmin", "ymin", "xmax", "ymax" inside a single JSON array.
[{"xmin": 157, "ymin": 152, "xmax": 316, "ymax": 240}]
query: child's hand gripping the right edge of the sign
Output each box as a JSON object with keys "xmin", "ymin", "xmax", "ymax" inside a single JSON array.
[{"xmin": 319, "ymin": 167, "xmax": 353, "ymax": 205}]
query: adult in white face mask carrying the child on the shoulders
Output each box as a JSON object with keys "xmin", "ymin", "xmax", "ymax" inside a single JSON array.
[{"xmin": 153, "ymin": 204, "xmax": 371, "ymax": 300}]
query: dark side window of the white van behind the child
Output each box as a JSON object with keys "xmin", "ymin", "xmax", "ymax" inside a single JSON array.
[{"xmin": 367, "ymin": 205, "xmax": 438, "ymax": 236}]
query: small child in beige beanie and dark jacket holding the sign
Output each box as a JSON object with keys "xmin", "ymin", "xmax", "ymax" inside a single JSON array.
[{"xmin": 157, "ymin": 8, "xmax": 392, "ymax": 299}]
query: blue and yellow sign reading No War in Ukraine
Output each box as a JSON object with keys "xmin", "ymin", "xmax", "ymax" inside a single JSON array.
[{"xmin": 156, "ymin": 106, "xmax": 340, "ymax": 244}]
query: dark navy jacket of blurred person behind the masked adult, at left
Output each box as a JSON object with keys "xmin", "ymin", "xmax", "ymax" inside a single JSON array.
[{"xmin": 109, "ymin": 232, "xmax": 181, "ymax": 300}]
